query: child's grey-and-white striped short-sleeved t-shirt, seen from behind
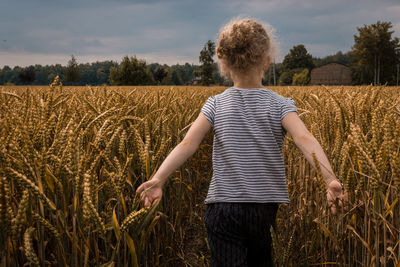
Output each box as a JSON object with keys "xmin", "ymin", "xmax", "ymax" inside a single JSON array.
[{"xmin": 201, "ymin": 87, "xmax": 297, "ymax": 203}]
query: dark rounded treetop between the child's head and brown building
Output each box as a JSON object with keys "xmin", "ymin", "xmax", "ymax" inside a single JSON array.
[{"xmin": 282, "ymin": 44, "xmax": 315, "ymax": 70}]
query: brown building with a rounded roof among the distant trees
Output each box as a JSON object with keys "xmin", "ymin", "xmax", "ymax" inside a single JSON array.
[{"xmin": 310, "ymin": 63, "xmax": 351, "ymax": 85}]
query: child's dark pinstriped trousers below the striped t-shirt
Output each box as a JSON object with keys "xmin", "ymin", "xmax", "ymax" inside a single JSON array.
[{"xmin": 204, "ymin": 203, "xmax": 278, "ymax": 267}]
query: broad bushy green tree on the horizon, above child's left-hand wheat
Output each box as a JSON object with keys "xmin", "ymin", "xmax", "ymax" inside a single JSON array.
[{"xmin": 110, "ymin": 56, "xmax": 154, "ymax": 85}]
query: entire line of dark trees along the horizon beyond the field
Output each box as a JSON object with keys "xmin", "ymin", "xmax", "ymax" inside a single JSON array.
[{"xmin": 0, "ymin": 21, "xmax": 400, "ymax": 85}]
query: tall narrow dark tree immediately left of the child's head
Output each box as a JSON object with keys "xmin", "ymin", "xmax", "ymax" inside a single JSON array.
[{"xmin": 199, "ymin": 40, "xmax": 215, "ymax": 86}]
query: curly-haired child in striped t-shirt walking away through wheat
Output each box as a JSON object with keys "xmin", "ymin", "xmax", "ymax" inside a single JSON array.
[{"xmin": 137, "ymin": 19, "xmax": 342, "ymax": 267}]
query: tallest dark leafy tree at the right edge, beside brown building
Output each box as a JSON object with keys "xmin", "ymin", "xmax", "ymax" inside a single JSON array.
[{"xmin": 352, "ymin": 21, "xmax": 400, "ymax": 85}]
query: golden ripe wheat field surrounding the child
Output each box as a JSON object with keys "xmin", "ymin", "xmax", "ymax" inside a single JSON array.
[{"xmin": 0, "ymin": 80, "xmax": 400, "ymax": 266}]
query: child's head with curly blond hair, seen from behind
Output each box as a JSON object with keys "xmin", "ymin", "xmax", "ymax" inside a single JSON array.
[{"xmin": 216, "ymin": 18, "xmax": 277, "ymax": 77}]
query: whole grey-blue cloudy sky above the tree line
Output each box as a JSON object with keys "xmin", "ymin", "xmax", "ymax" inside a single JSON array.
[{"xmin": 0, "ymin": 0, "xmax": 400, "ymax": 67}]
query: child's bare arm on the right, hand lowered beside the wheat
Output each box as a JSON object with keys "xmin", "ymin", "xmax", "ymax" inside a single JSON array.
[{"xmin": 282, "ymin": 112, "xmax": 343, "ymax": 214}]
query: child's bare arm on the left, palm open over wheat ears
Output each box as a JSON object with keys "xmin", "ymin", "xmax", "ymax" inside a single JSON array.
[{"xmin": 136, "ymin": 112, "xmax": 211, "ymax": 207}]
